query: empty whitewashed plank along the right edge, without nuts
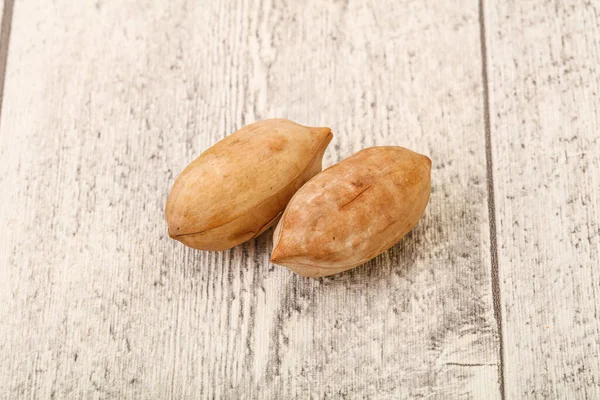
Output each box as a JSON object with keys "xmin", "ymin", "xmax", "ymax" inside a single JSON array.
[{"xmin": 485, "ymin": 0, "xmax": 600, "ymax": 399}]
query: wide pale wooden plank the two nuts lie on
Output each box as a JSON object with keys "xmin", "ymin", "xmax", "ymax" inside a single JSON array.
[{"xmin": 0, "ymin": 0, "xmax": 500, "ymax": 399}]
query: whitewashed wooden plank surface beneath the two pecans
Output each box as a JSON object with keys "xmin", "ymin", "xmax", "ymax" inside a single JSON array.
[{"xmin": 0, "ymin": 0, "xmax": 600, "ymax": 399}]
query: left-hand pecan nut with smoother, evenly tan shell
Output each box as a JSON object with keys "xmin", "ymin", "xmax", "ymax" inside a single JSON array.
[{"xmin": 165, "ymin": 119, "xmax": 333, "ymax": 250}]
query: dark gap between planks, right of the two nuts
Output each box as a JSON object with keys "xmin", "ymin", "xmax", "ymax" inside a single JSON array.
[{"xmin": 479, "ymin": 0, "xmax": 506, "ymax": 400}]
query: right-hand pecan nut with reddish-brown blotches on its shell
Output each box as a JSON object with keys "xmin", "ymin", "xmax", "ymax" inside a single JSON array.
[{"xmin": 271, "ymin": 146, "xmax": 431, "ymax": 277}]
